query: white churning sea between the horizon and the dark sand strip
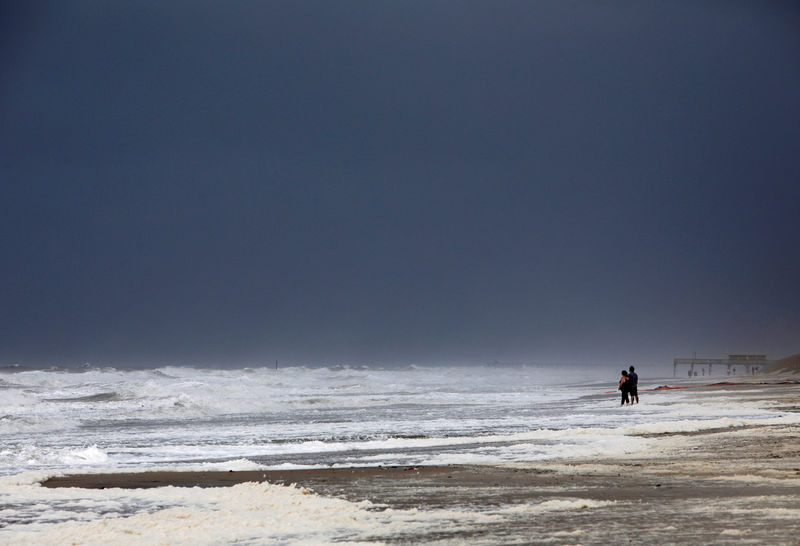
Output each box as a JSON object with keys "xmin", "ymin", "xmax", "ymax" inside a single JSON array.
[{"xmin": 0, "ymin": 367, "xmax": 790, "ymax": 473}]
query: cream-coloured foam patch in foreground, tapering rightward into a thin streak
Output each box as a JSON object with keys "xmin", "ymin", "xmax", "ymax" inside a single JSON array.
[{"xmin": 0, "ymin": 472, "xmax": 614, "ymax": 544}]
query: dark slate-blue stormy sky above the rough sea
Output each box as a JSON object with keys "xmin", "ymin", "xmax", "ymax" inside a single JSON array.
[{"xmin": 0, "ymin": 0, "xmax": 800, "ymax": 365}]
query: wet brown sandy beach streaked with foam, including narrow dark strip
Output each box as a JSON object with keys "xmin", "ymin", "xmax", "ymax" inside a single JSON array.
[{"xmin": 43, "ymin": 381, "xmax": 800, "ymax": 544}]
